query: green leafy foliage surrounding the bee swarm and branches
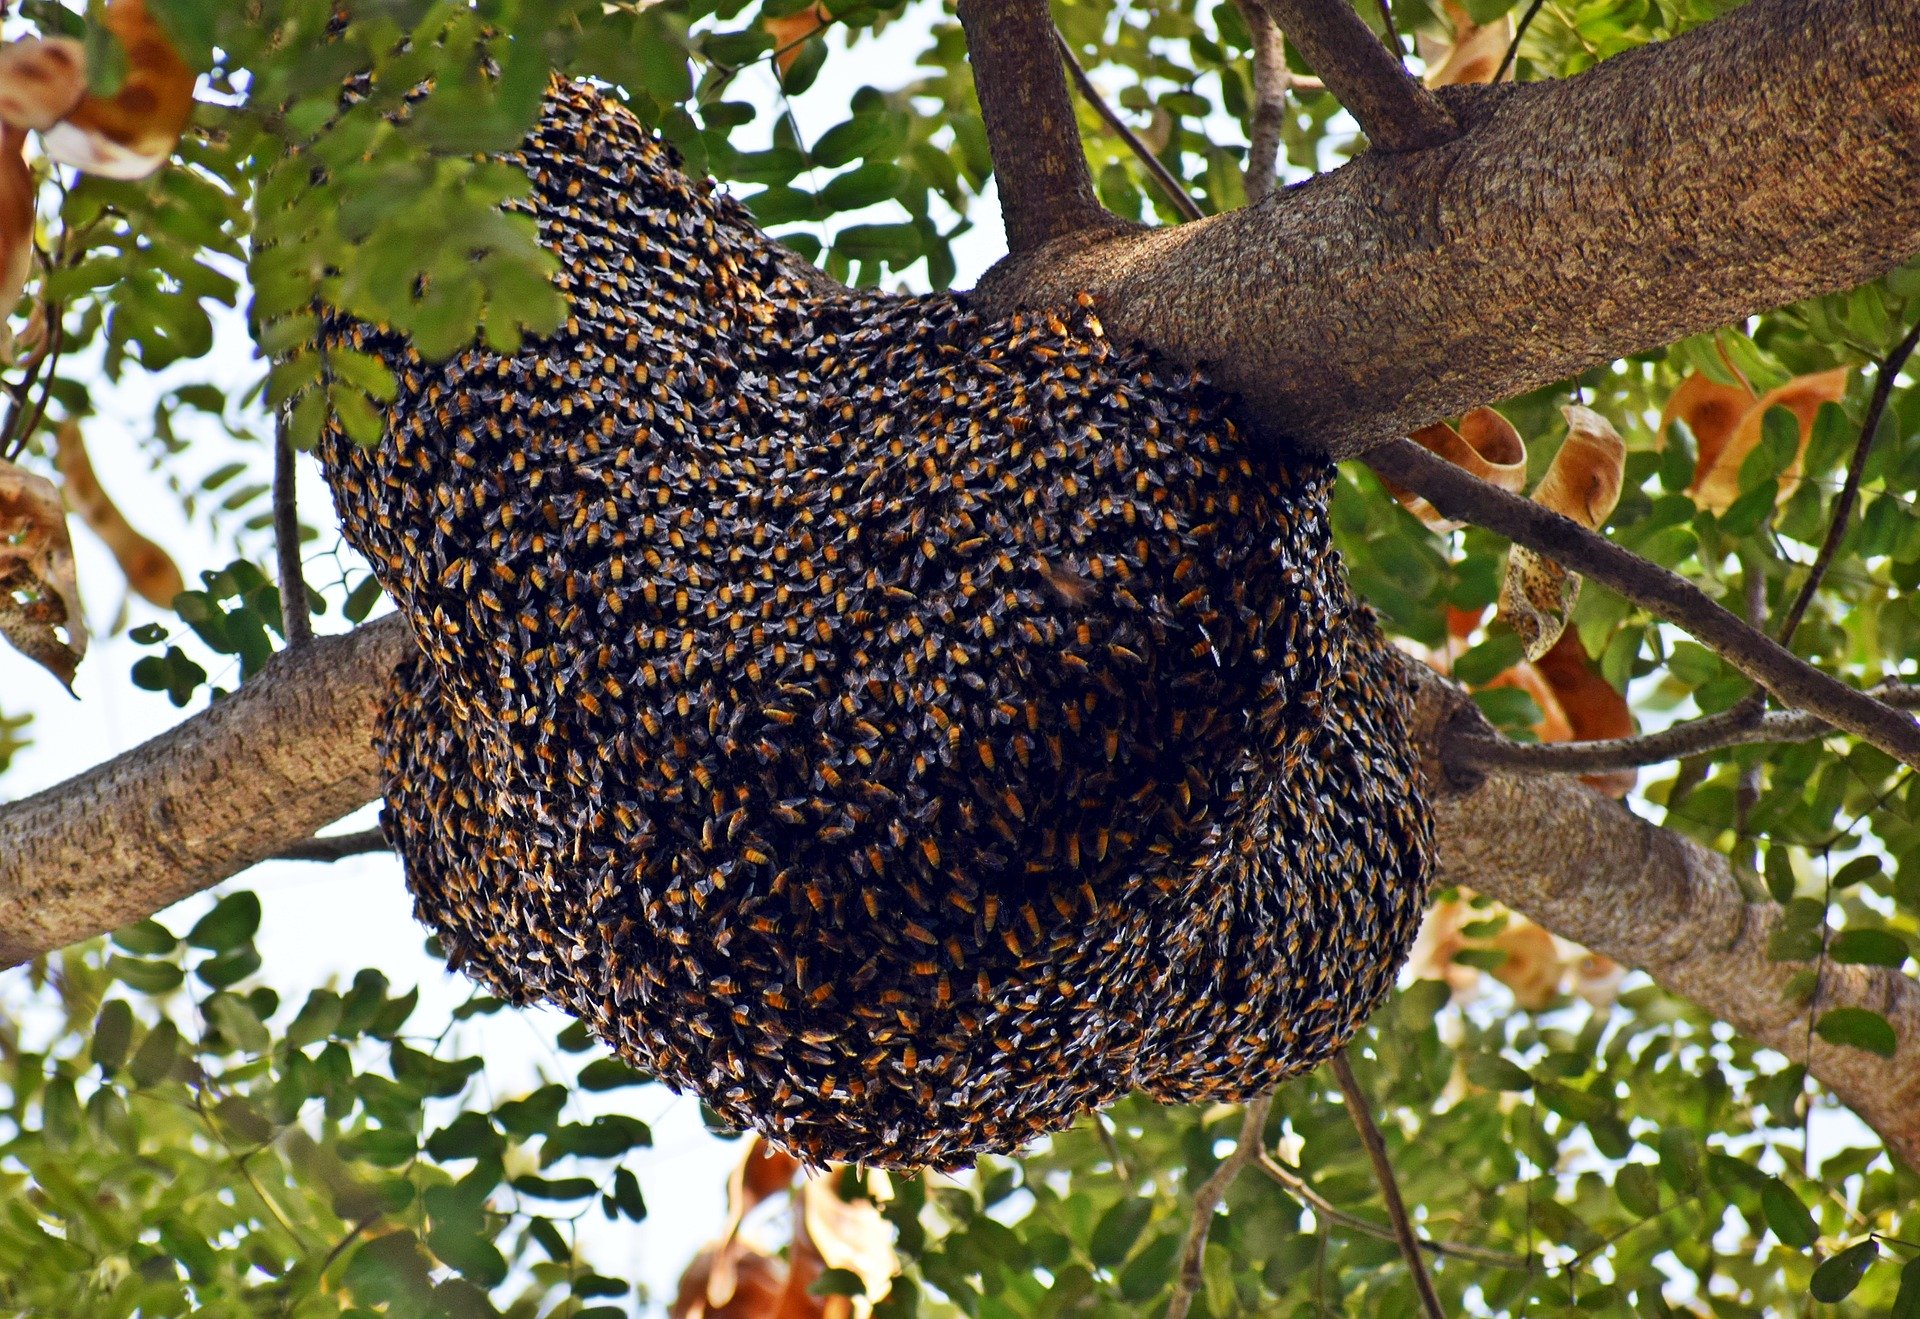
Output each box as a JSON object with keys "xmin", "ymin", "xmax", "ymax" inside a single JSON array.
[{"xmin": 0, "ymin": 0, "xmax": 1920, "ymax": 1319}]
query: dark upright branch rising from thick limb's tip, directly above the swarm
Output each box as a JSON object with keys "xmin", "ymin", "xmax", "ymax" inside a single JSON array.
[{"xmin": 960, "ymin": 0, "xmax": 1119, "ymax": 255}]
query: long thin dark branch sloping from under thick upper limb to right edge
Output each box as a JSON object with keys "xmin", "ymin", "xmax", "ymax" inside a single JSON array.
[{"xmin": 1367, "ymin": 440, "xmax": 1920, "ymax": 768}]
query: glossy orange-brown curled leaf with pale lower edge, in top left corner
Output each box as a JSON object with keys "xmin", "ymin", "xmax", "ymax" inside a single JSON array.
[{"xmin": 40, "ymin": 0, "xmax": 194, "ymax": 179}]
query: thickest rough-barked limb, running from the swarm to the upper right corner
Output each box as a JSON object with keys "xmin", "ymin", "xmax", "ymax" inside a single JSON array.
[{"xmin": 981, "ymin": 0, "xmax": 1920, "ymax": 457}]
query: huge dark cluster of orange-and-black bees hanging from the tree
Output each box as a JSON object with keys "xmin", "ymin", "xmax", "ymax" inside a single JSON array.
[{"xmin": 324, "ymin": 86, "xmax": 1430, "ymax": 1165}]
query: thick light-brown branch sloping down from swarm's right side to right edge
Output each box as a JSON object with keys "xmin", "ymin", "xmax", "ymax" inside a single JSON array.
[{"xmin": 1409, "ymin": 660, "xmax": 1920, "ymax": 1167}]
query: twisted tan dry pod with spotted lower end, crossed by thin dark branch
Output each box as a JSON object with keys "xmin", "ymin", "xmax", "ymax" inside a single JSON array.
[{"xmin": 1500, "ymin": 403, "xmax": 1626, "ymax": 660}]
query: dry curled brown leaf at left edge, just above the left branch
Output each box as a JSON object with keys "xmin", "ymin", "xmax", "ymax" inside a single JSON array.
[{"xmin": 0, "ymin": 459, "xmax": 86, "ymax": 691}]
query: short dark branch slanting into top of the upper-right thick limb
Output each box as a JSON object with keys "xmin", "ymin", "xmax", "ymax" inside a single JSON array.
[{"xmin": 1261, "ymin": 0, "xmax": 1459, "ymax": 152}]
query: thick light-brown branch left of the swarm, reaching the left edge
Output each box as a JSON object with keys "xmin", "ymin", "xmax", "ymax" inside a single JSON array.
[{"xmin": 0, "ymin": 618, "xmax": 413, "ymax": 968}]
